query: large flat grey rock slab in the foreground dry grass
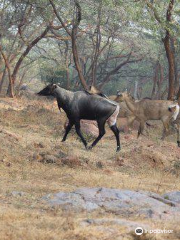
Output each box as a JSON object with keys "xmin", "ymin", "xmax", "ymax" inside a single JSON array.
[{"xmin": 43, "ymin": 188, "xmax": 180, "ymax": 219}]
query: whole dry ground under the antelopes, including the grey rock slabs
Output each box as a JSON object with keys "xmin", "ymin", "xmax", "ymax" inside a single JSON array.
[{"xmin": 0, "ymin": 94, "xmax": 180, "ymax": 240}]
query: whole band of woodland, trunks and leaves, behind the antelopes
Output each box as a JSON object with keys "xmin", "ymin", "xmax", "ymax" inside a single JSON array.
[{"xmin": 0, "ymin": 0, "xmax": 180, "ymax": 99}]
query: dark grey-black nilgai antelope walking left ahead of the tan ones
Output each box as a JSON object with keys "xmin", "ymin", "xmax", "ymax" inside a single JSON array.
[{"xmin": 38, "ymin": 84, "xmax": 120, "ymax": 151}]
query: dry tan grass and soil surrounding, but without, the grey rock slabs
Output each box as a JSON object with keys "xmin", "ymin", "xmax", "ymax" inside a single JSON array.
[{"xmin": 0, "ymin": 98, "xmax": 180, "ymax": 240}]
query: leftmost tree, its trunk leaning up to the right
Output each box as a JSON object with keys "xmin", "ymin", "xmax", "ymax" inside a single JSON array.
[{"xmin": 0, "ymin": 1, "xmax": 50, "ymax": 97}]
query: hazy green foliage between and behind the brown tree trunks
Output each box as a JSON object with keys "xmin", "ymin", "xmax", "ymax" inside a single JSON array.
[{"xmin": 0, "ymin": 0, "xmax": 180, "ymax": 95}]
